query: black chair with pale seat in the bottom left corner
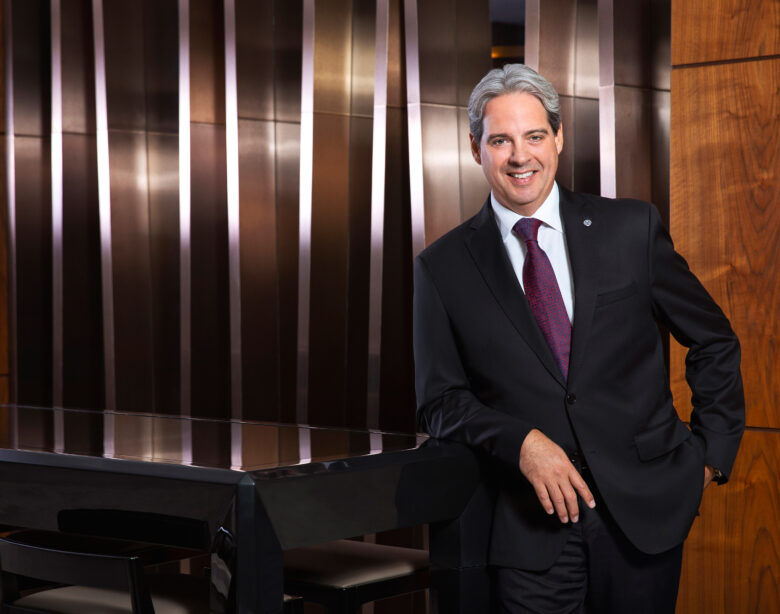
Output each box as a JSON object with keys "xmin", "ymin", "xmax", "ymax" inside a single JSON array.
[{"xmin": 0, "ymin": 532, "xmax": 302, "ymax": 614}]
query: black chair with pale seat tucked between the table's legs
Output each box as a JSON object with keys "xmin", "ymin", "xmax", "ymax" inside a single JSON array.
[{"xmin": 284, "ymin": 540, "xmax": 429, "ymax": 614}]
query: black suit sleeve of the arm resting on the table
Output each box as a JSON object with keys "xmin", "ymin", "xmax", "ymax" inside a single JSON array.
[{"xmin": 414, "ymin": 257, "xmax": 533, "ymax": 467}]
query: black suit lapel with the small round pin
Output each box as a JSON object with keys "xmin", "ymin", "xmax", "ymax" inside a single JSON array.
[{"xmin": 560, "ymin": 188, "xmax": 602, "ymax": 388}]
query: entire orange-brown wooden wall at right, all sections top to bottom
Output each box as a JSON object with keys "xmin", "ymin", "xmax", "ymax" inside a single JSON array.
[{"xmin": 670, "ymin": 0, "xmax": 780, "ymax": 614}]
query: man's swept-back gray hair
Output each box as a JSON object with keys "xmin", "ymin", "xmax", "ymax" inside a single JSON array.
[{"xmin": 468, "ymin": 64, "xmax": 561, "ymax": 143}]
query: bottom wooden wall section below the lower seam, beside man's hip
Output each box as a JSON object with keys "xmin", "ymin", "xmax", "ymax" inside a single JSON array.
[{"xmin": 677, "ymin": 431, "xmax": 780, "ymax": 614}]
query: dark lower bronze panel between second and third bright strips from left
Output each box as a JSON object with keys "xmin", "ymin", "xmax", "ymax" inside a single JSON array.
[{"xmin": 62, "ymin": 134, "xmax": 105, "ymax": 412}]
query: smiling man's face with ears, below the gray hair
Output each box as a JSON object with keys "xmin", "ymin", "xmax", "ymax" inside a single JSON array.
[{"xmin": 469, "ymin": 92, "xmax": 563, "ymax": 216}]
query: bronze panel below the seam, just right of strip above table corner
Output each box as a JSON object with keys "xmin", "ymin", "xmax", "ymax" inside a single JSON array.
[{"xmin": 238, "ymin": 120, "xmax": 279, "ymax": 420}]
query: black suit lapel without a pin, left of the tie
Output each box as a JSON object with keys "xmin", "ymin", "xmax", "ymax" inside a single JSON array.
[{"xmin": 466, "ymin": 197, "xmax": 566, "ymax": 387}]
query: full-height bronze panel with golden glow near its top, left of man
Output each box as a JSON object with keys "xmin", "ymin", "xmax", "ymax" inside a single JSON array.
[{"xmin": 308, "ymin": 2, "xmax": 376, "ymax": 426}]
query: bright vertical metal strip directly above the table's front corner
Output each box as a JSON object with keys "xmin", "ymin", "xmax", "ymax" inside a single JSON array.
[{"xmin": 224, "ymin": 0, "xmax": 243, "ymax": 467}]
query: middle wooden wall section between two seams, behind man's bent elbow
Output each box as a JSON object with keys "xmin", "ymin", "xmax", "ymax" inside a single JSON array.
[{"xmin": 670, "ymin": 59, "xmax": 780, "ymax": 428}]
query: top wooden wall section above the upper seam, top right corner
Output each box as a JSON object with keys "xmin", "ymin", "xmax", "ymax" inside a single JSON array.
[{"xmin": 672, "ymin": 0, "xmax": 780, "ymax": 65}]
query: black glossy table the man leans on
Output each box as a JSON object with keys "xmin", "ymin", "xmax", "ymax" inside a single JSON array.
[{"xmin": 0, "ymin": 407, "xmax": 486, "ymax": 614}]
